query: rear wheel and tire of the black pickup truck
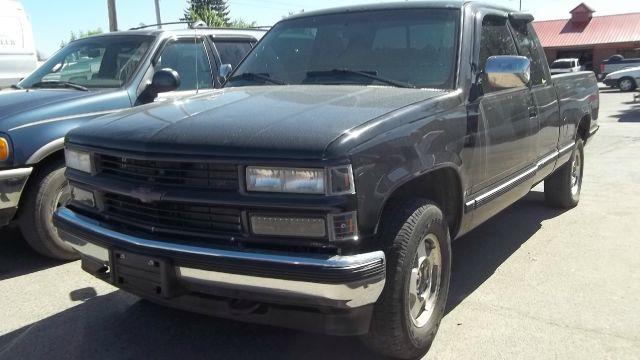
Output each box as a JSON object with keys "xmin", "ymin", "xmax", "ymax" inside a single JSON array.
[{"xmin": 544, "ymin": 139, "xmax": 584, "ymax": 208}]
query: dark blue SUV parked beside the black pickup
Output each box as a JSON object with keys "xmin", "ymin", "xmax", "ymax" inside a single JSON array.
[{"xmin": 0, "ymin": 25, "xmax": 266, "ymax": 259}]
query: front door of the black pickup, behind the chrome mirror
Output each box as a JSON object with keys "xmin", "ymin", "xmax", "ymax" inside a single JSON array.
[{"xmin": 470, "ymin": 15, "xmax": 538, "ymax": 193}]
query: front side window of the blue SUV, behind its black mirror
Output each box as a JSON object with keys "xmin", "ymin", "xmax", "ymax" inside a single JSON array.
[{"xmin": 155, "ymin": 39, "xmax": 213, "ymax": 91}]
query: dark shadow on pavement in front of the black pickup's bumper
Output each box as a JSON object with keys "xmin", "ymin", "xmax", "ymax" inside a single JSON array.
[{"xmin": 0, "ymin": 291, "xmax": 376, "ymax": 360}]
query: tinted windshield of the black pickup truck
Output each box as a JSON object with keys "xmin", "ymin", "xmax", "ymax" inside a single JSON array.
[{"xmin": 226, "ymin": 9, "xmax": 460, "ymax": 89}]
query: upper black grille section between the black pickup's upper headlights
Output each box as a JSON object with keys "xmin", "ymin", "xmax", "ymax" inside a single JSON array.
[{"xmin": 96, "ymin": 155, "xmax": 239, "ymax": 191}]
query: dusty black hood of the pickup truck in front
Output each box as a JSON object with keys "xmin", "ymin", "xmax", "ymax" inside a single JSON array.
[{"xmin": 67, "ymin": 85, "xmax": 447, "ymax": 159}]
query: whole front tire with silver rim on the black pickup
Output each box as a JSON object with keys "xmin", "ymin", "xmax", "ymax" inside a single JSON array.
[{"xmin": 364, "ymin": 200, "xmax": 451, "ymax": 359}]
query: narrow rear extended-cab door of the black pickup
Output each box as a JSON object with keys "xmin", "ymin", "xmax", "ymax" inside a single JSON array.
[{"xmin": 511, "ymin": 22, "xmax": 560, "ymax": 180}]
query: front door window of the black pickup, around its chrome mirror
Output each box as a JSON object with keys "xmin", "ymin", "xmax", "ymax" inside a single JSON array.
[{"xmin": 478, "ymin": 16, "xmax": 518, "ymax": 94}]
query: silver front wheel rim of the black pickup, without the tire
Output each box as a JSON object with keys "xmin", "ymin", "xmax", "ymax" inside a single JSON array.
[{"xmin": 407, "ymin": 234, "xmax": 442, "ymax": 327}]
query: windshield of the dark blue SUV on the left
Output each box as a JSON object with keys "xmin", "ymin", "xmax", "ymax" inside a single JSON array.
[{"xmin": 19, "ymin": 35, "xmax": 154, "ymax": 89}]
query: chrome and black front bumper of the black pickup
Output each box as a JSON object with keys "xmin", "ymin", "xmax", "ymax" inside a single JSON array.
[{"xmin": 54, "ymin": 208, "xmax": 386, "ymax": 335}]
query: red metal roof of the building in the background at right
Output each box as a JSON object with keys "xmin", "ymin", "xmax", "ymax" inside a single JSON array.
[{"xmin": 533, "ymin": 13, "xmax": 640, "ymax": 48}]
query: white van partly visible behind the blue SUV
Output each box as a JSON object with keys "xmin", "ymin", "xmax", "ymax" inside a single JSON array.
[{"xmin": 0, "ymin": 0, "xmax": 38, "ymax": 89}]
